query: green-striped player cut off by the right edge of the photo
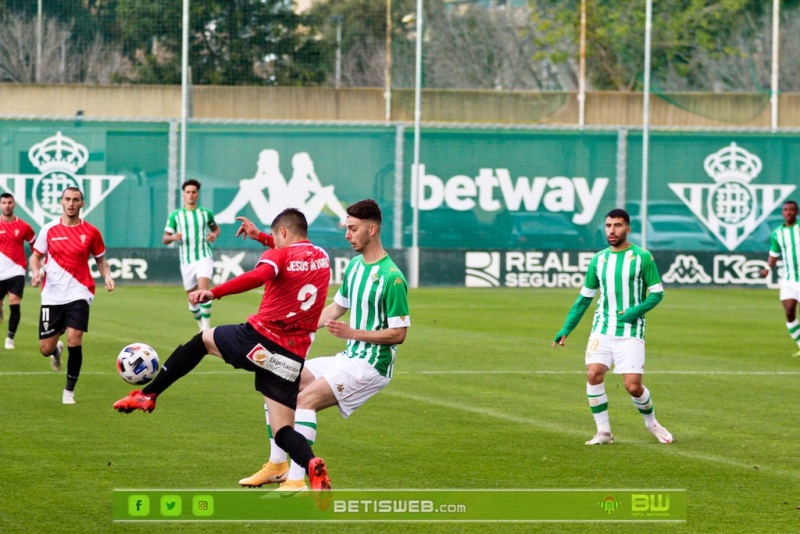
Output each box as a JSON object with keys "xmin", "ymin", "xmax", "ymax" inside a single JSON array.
[{"xmin": 761, "ymin": 200, "xmax": 800, "ymax": 356}]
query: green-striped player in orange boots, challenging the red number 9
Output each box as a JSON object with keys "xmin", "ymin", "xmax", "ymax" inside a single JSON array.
[{"xmin": 237, "ymin": 200, "xmax": 411, "ymax": 492}]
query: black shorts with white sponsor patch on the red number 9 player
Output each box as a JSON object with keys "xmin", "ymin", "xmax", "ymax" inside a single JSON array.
[{"xmin": 214, "ymin": 323, "xmax": 305, "ymax": 410}]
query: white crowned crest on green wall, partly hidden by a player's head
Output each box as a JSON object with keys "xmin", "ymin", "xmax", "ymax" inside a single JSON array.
[{"xmin": 0, "ymin": 131, "xmax": 125, "ymax": 226}]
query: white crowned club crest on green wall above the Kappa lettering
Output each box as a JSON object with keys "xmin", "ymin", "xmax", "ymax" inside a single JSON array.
[{"xmin": 669, "ymin": 143, "xmax": 796, "ymax": 251}]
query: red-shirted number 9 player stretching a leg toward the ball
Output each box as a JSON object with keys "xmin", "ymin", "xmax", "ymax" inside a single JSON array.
[{"xmin": 114, "ymin": 208, "xmax": 331, "ymax": 498}]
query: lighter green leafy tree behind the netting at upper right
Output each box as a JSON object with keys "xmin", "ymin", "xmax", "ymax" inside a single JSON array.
[{"xmin": 531, "ymin": 0, "xmax": 798, "ymax": 90}]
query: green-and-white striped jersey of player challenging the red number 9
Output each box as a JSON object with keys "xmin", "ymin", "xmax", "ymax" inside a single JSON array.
[{"xmin": 333, "ymin": 255, "xmax": 411, "ymax": 377}]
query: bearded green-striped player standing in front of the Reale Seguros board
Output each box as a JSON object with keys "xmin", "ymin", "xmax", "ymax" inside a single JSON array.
[{"xmin": 553, "ymin": 209, "xmax": 673, "ymax": 445}]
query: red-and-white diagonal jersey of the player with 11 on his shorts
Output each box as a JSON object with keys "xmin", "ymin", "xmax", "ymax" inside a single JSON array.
[{"xmin": 33, "ymin": 219, "xmax": 106, "ymax": 304}]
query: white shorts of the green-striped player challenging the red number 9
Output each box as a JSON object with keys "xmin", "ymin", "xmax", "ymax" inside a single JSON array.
[{"xmin": 305, "ymin": 352, "xmax": 391, "ymax": 417}]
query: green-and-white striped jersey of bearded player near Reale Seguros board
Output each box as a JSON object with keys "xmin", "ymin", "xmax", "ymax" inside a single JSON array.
[{"xmin": 581, "ymin": 244, "xmax": 664, "ymax": 339}]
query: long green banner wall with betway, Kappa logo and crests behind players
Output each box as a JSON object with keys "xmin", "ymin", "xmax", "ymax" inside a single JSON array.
[{"xmin": 0, "ymin": 120, "xmax": 800, "ymax": 287}]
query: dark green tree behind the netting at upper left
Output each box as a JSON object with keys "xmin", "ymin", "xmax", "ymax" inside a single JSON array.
[{"xmin": 117, "ymin": 0, "xmax": 323, "ymax": 85}]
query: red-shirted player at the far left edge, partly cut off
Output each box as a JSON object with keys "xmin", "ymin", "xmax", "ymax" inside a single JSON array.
[{"xmin": 0, "ymin": 193, "xmax": 36, "ymax": 349}]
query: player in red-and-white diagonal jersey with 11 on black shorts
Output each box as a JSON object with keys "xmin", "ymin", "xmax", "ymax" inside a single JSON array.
[{"xmin": 30, "ymin": 187, "xmax": 114, "ymax": 404}]
